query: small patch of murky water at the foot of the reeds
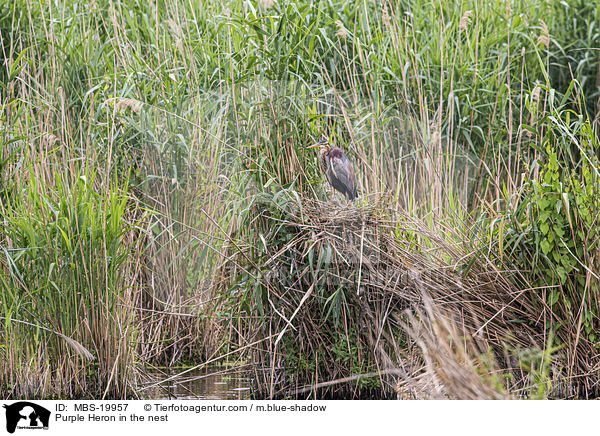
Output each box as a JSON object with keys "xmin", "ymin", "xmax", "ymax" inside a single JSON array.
[{"xmin": 139, "ymin": 366, "xmax": 251, "ymax": 400}]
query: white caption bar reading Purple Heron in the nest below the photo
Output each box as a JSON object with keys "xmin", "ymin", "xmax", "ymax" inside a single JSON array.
[{"xmin": 0, "ymin": 400, "xmax": 600, "ymax": 436}]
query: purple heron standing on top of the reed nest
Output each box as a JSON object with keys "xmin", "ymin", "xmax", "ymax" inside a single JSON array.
[{"xmin": 308, "ymin": 139, "xmax": 358, "ymax": 200}]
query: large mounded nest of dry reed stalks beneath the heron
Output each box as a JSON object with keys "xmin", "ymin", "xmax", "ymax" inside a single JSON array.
[{"xmin": 219, "ymin": 197, "xmax": 592, "ymax": 398}]
